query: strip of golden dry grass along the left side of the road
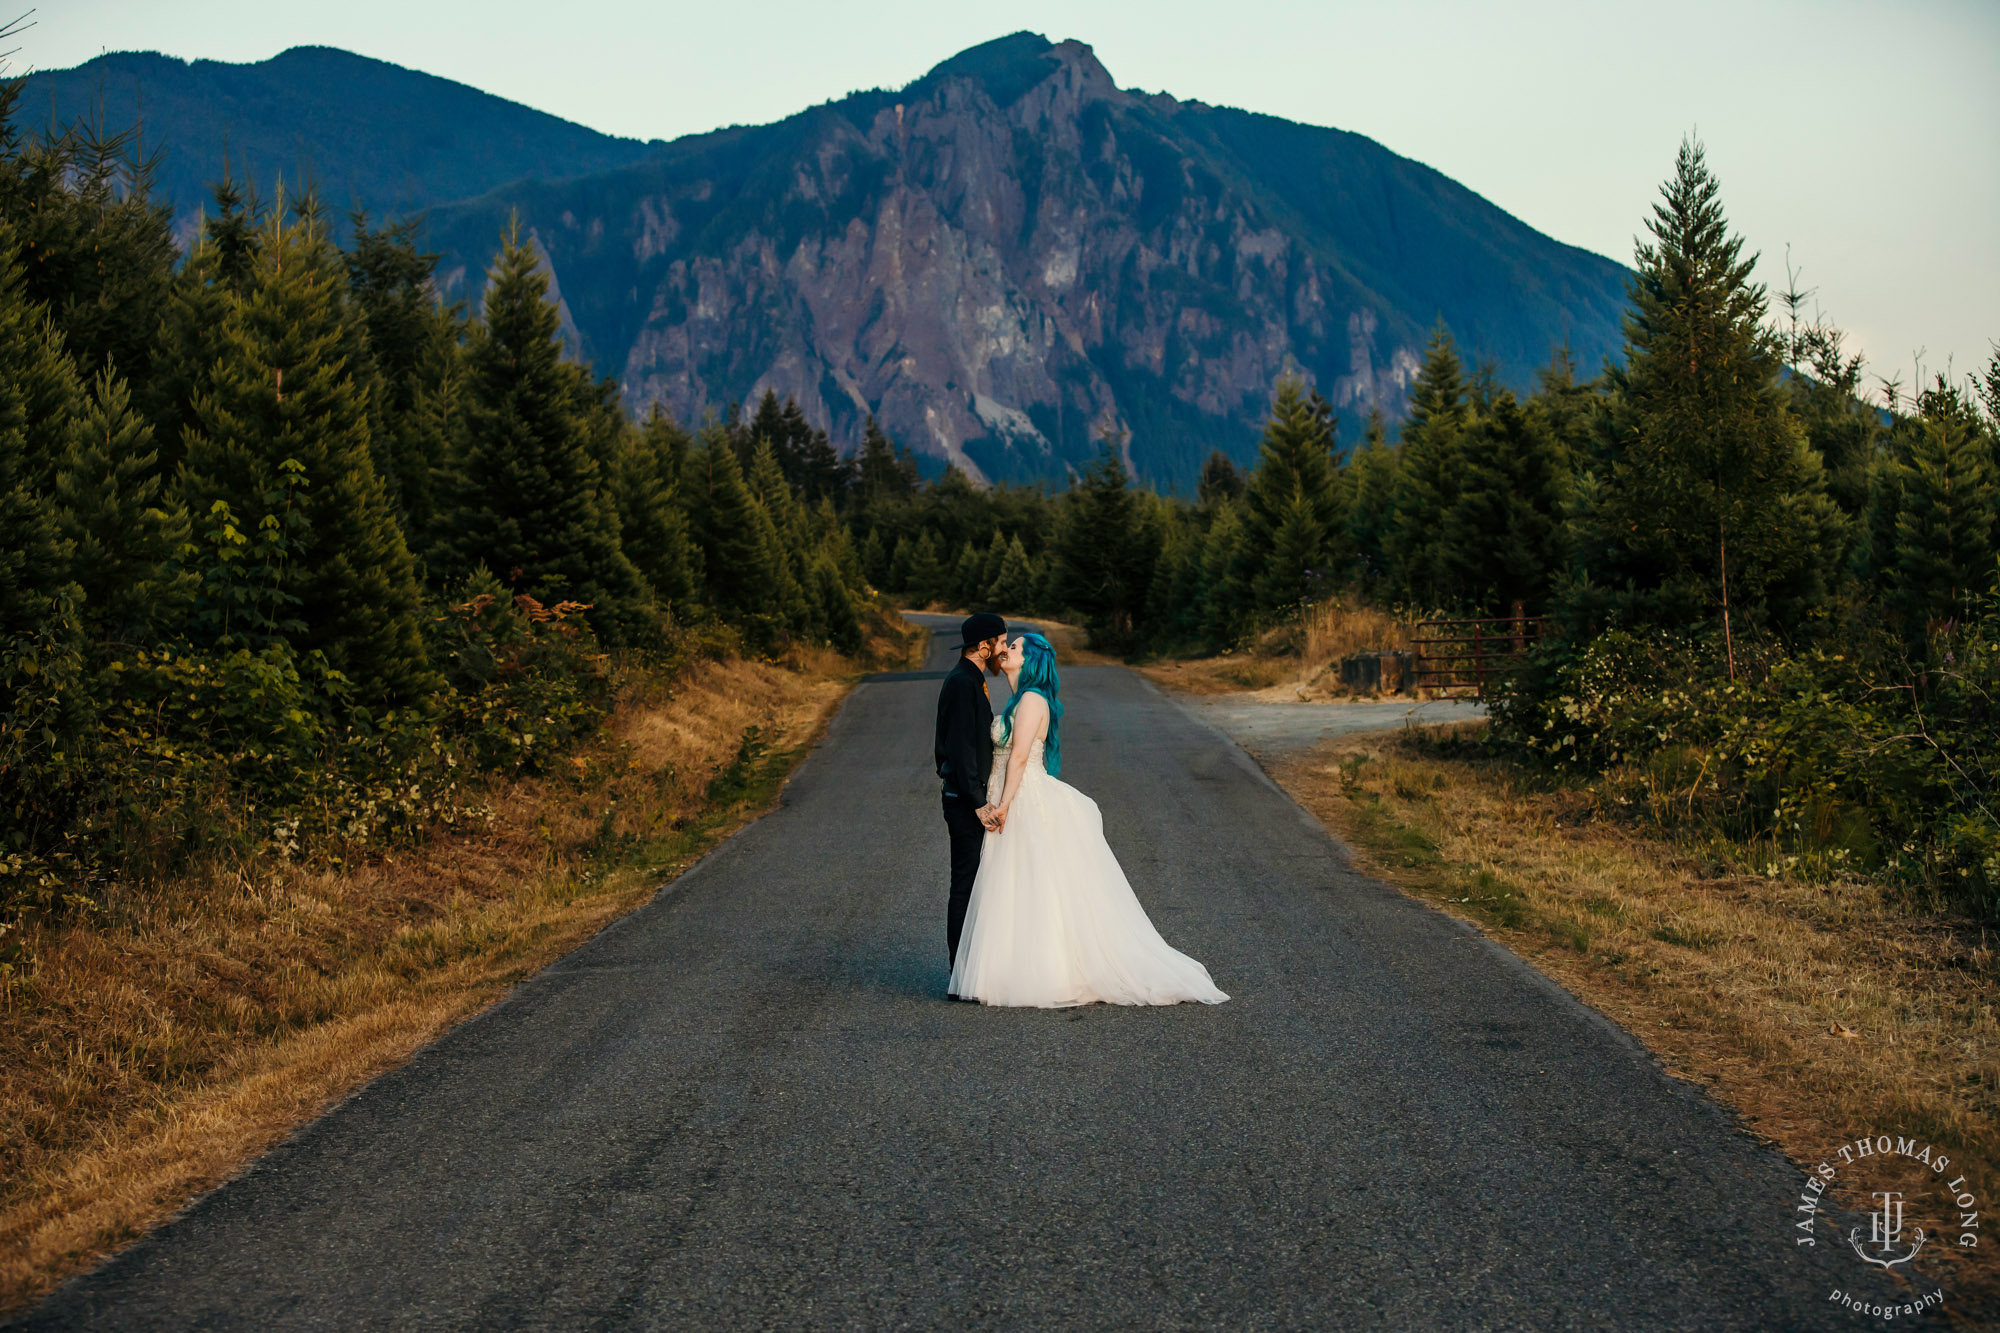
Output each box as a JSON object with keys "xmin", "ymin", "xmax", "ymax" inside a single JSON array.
[{"xmin": 0, "ymin": 624, "xmax": 908, "ymax": 1309}]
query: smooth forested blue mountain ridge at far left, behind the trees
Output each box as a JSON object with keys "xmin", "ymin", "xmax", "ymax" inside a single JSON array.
[{"xmin": 20, "ymin": 46, "xmax": 656, "ymax": 240}]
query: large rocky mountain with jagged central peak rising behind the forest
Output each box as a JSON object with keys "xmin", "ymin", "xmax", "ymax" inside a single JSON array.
[{"xmin": 432, "ymin": 34, "xmax": 1624, "ymax": 488}]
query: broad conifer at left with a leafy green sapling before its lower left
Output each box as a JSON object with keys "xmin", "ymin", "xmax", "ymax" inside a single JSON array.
[{"xmin": 180, "ymin": 202, "xmax": 436, "ymax": 705}]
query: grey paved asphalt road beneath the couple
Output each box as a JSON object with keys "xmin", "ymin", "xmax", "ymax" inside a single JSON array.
[{"xmin": 20, "ymin": 620, "xmax": 1920, "ymax": 1329}]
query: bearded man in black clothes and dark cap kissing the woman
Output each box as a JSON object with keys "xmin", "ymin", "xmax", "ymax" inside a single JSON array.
[{"xmin": 936, "ymin": 610, "xmax": 1006, "ymax": 967}]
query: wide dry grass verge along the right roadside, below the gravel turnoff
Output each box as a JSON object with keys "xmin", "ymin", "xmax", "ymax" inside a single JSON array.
[{"xmin": 1272, "ymin": 720, "xmax": 2000, "ymax": 1309}]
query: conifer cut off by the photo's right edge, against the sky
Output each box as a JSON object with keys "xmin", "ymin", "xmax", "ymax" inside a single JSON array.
[{"xmin": 1890, "ymin": 376, "xmax": 2000, "ymax": 630}]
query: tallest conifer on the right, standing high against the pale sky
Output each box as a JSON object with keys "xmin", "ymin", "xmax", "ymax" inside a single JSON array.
[{"xmin": 1604, "ymin": 142, "xmax": 1838, "ymax": 677}]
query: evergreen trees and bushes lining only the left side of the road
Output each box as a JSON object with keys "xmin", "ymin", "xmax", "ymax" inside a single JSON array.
[{"xmin": 0, "ymin": 84, "xmax": 878, "ymax": 924}]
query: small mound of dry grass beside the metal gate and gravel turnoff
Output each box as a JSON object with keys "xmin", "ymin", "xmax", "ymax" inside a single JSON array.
[{"xmin": 1140, "ymin": 600, "xmax": 1410, "ymax": 703}]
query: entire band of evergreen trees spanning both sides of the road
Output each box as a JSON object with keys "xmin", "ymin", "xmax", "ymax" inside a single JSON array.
[{"xmin": 0, "ymin": 88, "xmax": 2000, "ymax": 920}]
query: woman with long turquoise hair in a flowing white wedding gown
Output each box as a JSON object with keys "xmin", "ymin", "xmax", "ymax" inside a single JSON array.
[{"xmin": 952, "ymin": 632, "xmax": 1228, "ymax": 1009}]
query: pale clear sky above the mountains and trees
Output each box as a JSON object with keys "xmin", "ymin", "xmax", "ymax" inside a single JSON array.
[{"xmin": 19, "ymin": 0, "xmax": 2000, "ymax": 400}]
